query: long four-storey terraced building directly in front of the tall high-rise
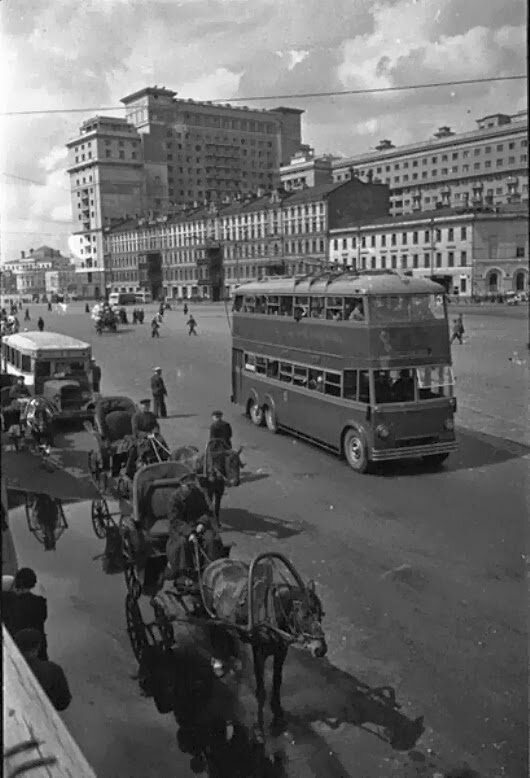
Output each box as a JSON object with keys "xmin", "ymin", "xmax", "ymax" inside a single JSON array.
[{"xmin": 106, "ymin": 179, "xmax": 388, "ymax": 300}]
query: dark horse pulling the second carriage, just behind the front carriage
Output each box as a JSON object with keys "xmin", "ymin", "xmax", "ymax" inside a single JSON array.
[{"xmin": 170, "ymin": 440, "xmax": 244, "ymax": 522}]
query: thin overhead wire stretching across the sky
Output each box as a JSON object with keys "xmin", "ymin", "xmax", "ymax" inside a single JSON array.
[{"xmin": 0, "ymin": 74, "xmax": 526, "ymax": 116}]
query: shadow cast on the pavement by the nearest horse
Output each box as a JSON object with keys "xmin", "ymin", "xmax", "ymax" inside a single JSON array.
[{"xmin": 283, "ymin": 651, "xmax": 424, "ymax": 751}]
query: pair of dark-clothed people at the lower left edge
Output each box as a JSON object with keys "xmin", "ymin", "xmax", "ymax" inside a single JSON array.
[{"xmin": 2, "ymin": 567, "xmax": 72, "ymax": 711}]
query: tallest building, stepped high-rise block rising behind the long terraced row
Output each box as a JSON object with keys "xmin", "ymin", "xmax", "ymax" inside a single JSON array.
[{"xmin": 67, "ymin": 87, "xmax": 303, "ymax": 296}]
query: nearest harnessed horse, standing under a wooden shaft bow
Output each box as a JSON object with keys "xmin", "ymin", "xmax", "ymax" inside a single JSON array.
[{"xmin": 201, "ymin": 553, "xmax": 327, "ymax": 733}]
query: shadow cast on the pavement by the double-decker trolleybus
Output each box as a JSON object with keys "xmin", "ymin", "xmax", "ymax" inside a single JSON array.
[{"xmin": 377, "ymin": 428, "xmax": 530, "ymax": 477}]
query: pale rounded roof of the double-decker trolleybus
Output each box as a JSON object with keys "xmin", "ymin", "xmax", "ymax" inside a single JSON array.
[{"xmin": 235, "ymin": 273, "xmax": 445, "ymax": 297}]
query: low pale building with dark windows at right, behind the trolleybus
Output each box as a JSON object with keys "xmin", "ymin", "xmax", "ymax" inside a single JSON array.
[{"xmin": 329, "ymin": 202, "xmax": 528, "ymax": 296}]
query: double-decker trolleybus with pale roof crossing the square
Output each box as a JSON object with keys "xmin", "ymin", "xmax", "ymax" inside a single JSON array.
[{"xmin": 232, "ymin": 271, "xmax": 457, "ymax": 473}]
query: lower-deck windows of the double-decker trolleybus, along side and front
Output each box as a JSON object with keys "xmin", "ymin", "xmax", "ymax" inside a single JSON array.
[{"xmin": 244, "ymin": 353, "xmax": 454, "ymax": 404}]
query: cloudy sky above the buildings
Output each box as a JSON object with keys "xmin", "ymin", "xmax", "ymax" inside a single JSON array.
[{"xmin": 0, "ymin": 0, "xmax": 526, "ymax": 259}]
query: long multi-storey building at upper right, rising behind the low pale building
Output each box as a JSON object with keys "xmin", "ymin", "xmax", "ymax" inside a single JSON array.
[{"xmin": 333, "ymin": 111, "xmax": 528, "ymax": 215}]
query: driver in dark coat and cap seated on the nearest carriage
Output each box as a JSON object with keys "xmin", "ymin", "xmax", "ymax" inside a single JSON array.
[{"xmin": 166, "ymin": 484, "xmax": 225, "ymax": 586}]
